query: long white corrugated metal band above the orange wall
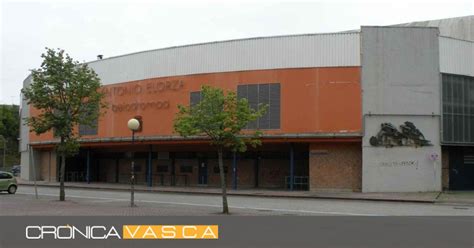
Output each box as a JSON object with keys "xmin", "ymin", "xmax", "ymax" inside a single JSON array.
[{"xmin": 89, "ymin": 33, "xmax": 360, "ymax": 85}]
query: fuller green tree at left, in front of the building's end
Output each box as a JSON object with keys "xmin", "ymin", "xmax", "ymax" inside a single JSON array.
[{"xmin": 22, "ymin": 48, "xmax": 106, "ymax": 201}]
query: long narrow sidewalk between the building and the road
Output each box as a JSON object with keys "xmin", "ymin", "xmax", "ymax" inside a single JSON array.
[{"xmin": 18, "ymin": 179, "xmax": 462, "ymax": 205}]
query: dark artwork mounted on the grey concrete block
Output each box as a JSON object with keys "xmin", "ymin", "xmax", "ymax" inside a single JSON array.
[{"xmin": 369, "ymin": 121, "xmax": 432, "ymax": 147}]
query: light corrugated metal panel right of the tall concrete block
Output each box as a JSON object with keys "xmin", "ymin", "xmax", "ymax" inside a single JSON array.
[{"xmin": 439, "ymin": 37, "xmax": 474, "ymax": 76}]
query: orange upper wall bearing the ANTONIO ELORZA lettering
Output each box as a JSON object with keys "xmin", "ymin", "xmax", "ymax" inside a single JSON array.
[{"xmin": 30, "ymin": 67, "xmax": 362, "ymax": 142}]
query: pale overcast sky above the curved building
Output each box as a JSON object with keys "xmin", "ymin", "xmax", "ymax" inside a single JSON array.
[{"xmin": 0, "ymin": 0, "xmax": 474, "ymax": 104}]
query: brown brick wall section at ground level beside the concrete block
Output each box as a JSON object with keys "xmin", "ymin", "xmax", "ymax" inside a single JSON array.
[{"xmin": 309, "ymin": 143, "xmax": 362, "ymax": 191}]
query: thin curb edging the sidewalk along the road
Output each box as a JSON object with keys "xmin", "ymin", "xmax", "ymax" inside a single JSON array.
[{"xmin": 19, "ymin": 183, "xmax": 437, "ymax": 203}]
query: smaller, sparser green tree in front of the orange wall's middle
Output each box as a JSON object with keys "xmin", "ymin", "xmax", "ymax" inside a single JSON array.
[{"xmin": 174, "ymin": 86, "xmax": 267, "ymax": 214}]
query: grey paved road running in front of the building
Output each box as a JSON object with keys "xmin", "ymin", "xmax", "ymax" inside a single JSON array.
[{"xmin": 0, "ymin": 186, "xmax": 474, "ymax": 216}]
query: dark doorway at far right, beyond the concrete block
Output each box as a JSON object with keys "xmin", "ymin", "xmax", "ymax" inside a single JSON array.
[{"xmin": 448, "ymin": 147, "xmax": 474, "ymax": 190}]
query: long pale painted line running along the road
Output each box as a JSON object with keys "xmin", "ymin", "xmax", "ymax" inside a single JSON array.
[{"xmin": 17, "ymin": 192, "xmax": 380, "ymax": 216}]
